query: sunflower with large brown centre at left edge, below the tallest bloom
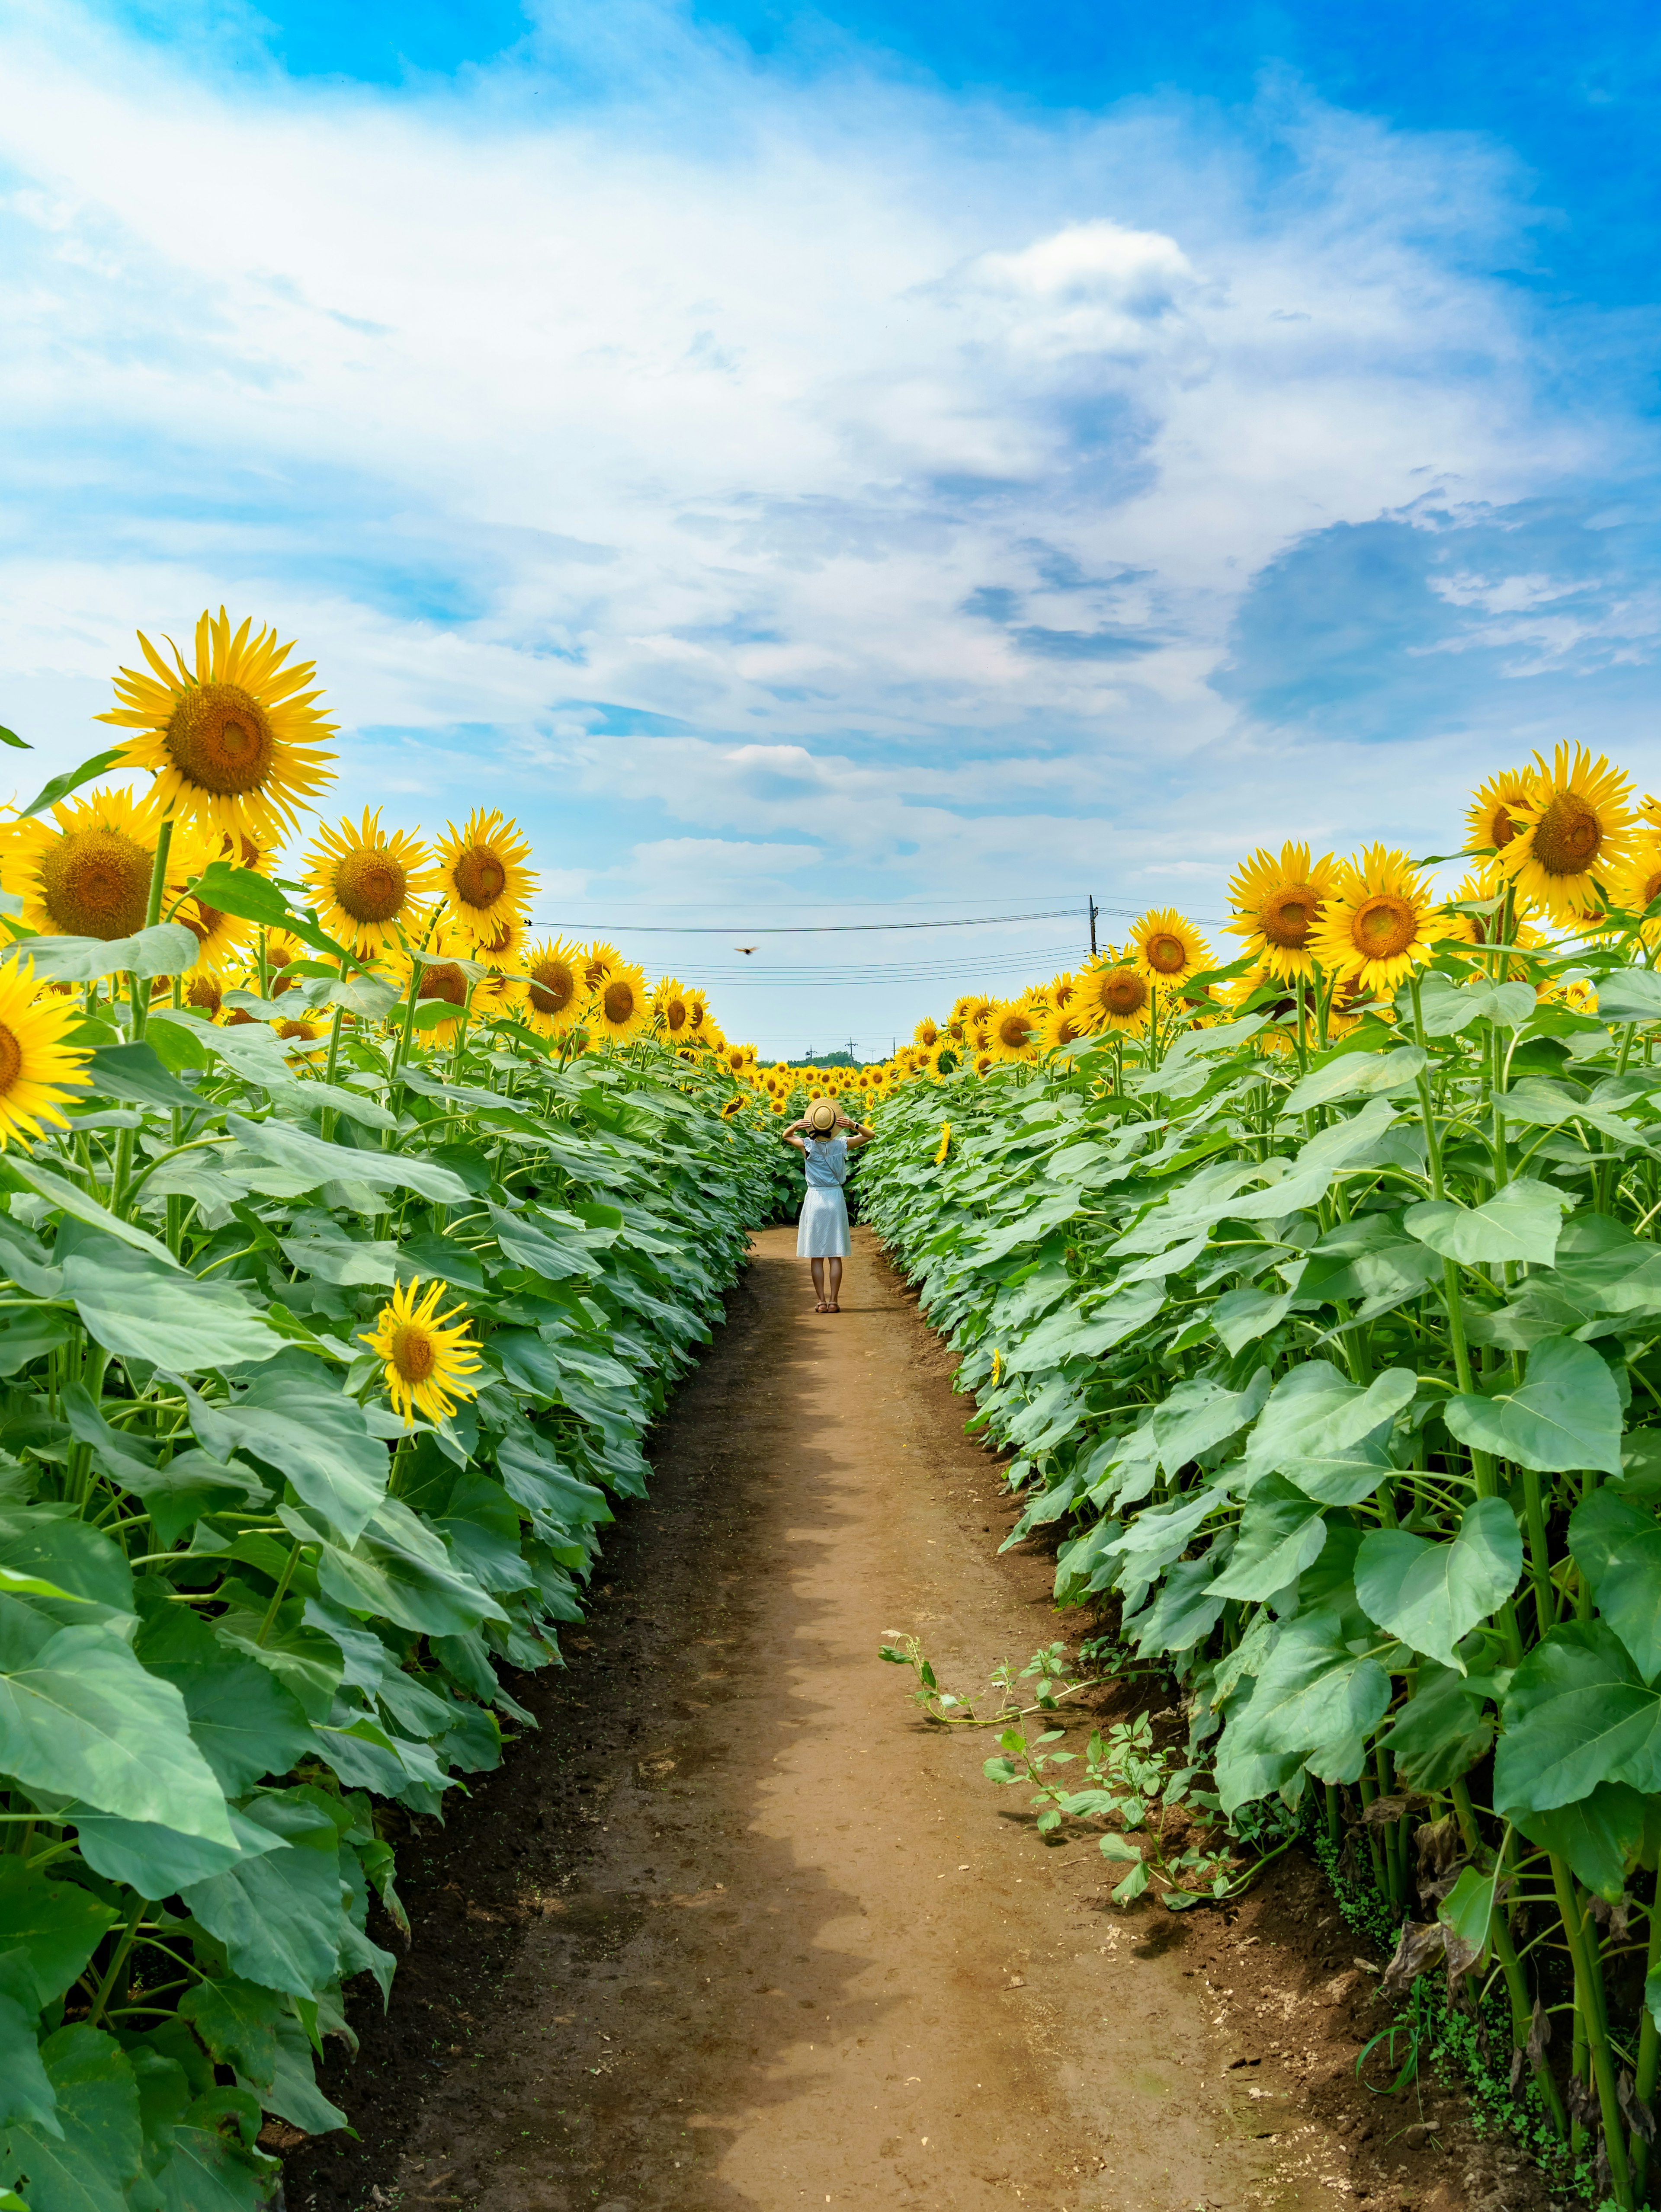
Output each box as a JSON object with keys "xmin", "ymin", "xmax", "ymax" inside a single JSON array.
[{"xmin": 0, "ymin": 792, "xmax": 183, "ymax": 944}]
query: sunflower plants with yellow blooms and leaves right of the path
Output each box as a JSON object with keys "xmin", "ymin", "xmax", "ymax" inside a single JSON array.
[{"xmin": 860, "ymin": 750, "xmax": 1661, "ymax": 2208}]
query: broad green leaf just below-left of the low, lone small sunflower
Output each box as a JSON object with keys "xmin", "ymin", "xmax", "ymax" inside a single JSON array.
[{"xmin": 186, "ymin": 1354, "xmax": 389, "ymax": 1544}]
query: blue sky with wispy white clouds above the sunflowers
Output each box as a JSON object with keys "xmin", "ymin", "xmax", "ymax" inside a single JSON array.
[{"xmin": 0, "ymin": 0, "xmax": 1661, "ymax": 1051}]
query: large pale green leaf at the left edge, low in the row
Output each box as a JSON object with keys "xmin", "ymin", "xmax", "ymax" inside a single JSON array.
[{"xmin": 0, "ymin": 1626, "xmax": 232, "ymax": 1843}]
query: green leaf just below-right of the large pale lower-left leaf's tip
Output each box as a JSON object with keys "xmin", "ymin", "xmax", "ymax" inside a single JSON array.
[{"xmin": 181, "ymin": 1796, "xmax": 343, "ymax": 1998}]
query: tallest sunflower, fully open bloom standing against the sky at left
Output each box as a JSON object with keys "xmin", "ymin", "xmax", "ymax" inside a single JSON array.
[{"xmin": 97, "ymin": 606, "xmax": 334, "ymax": 845}]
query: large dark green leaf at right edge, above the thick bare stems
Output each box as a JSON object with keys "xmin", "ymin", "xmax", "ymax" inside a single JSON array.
[{"xmin": 1493, "ymin": 1621, "xmax": 1661, "ymax": 1821}]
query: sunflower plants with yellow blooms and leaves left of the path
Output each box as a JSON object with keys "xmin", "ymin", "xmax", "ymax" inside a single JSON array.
[{"xmin": 0, "ymin": 611, "xmax": 789, "ymax": 2212}]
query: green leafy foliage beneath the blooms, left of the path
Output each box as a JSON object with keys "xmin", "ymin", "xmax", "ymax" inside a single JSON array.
[{"xmin": 0, "ymin": 927, "xmax": 783, "ymax": 2212}]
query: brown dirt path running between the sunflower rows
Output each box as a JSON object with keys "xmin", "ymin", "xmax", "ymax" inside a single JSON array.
[{"xmin": 288, "ymin": 1228, "xmax": 1544, "ymax": 2212}]
